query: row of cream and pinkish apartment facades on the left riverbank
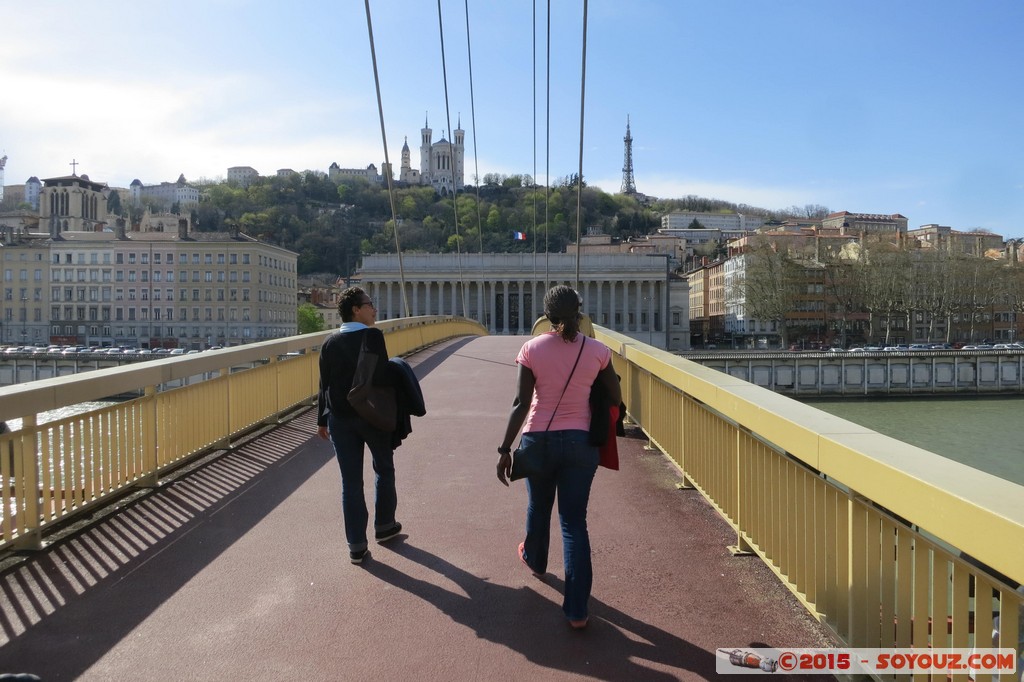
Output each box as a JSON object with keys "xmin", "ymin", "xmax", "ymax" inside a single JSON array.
[{"xmin": 0, "ymin": 219, "xmax": 297, "ymax": 348}]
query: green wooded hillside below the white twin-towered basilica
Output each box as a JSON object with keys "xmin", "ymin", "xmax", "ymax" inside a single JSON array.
[{"xmin": 151, "ymin": 171, "xmax": 772, "ymax": 276}]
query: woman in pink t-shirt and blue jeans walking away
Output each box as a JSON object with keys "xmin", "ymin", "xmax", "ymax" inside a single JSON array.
[{"xmin": 498, "ymin": 286, "xmax": 622, "ymax": 630}]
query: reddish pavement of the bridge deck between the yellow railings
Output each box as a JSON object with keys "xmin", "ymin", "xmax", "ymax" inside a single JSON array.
[{"xmin": 0, "ymin": 337, "xmax": 828, "ymax": 681}]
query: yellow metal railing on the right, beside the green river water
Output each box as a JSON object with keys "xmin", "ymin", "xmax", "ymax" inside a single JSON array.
[{"xmin": 595, "ymin": 328, "xmax": 1024, "ymax": 667}]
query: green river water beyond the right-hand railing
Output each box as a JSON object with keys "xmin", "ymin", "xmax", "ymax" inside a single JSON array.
[{"xmin": 802, "ymin": 395, "xmax": 1024, "ymax": 485}]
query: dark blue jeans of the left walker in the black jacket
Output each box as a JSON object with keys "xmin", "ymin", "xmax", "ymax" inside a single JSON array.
[{"xmin": 328, "ymin": 415, "xmax": 398, "ymax": 552}]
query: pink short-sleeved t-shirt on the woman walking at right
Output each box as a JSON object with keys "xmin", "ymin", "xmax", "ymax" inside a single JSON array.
[{"xmin": 515, "ymin": 332, "xmax": 611, "ymax": 432}]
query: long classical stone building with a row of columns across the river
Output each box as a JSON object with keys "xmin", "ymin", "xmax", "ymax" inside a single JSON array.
[{"xmin": 355, "ymin": 253, "xmax": 690, "ymax": 350}]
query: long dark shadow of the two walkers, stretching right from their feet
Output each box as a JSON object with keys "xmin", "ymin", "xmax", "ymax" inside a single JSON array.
[{"xmin": 366, "ymin": 542, "xmax": 716, "ymax": 680}]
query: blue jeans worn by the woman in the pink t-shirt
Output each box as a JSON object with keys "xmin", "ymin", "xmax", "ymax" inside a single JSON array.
[{"xmin": 521, "ymin": 430, "xmax": 600, "ymax": 621}]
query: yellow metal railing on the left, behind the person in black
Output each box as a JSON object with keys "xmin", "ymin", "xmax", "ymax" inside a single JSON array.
[{"xmin": 0, "ymin": 317, "xmax": 486, "ymax": 551}]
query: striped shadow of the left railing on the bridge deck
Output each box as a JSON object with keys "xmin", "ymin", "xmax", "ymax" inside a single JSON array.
[{"xmin": 0, "ymin": 411, "xmax": 323, "ymax": 679}]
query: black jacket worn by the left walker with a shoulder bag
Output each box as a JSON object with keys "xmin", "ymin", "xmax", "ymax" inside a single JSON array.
[{"xmin": 316, "ymin": 327, "xmax": 398, "ymax": 426}]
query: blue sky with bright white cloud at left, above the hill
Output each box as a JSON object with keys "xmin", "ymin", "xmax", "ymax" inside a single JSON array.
[{"xmin": 0, "ymin": 0, "xmax": 1024, "ymax": 237}]
